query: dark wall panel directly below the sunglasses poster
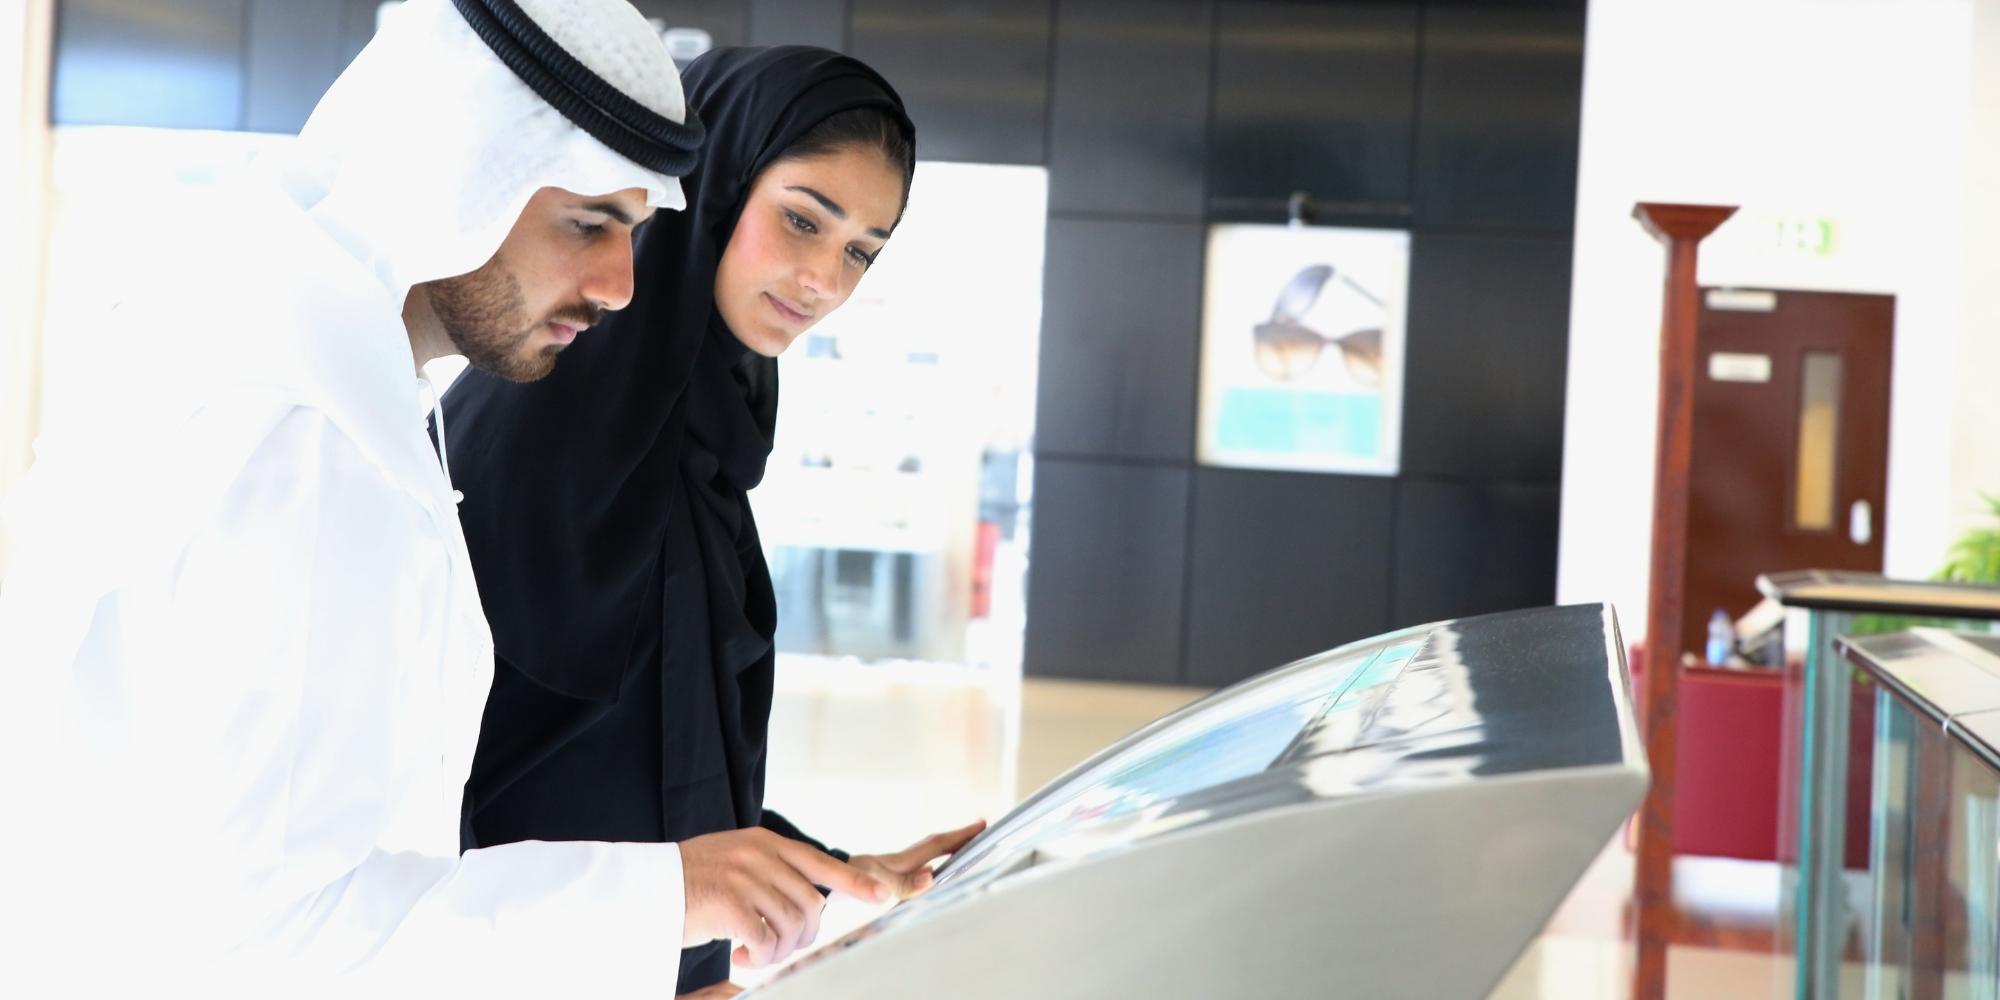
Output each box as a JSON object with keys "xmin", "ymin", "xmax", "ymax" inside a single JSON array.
[{"xmin": 1184, "ymin": 468, "xmax": 1396, "ymax": 686}]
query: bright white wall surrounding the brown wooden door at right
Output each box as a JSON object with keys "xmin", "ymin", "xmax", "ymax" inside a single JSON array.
[{"xmin": 1556, "ymin": 0, "xmax": 2000, "ymax": 640}]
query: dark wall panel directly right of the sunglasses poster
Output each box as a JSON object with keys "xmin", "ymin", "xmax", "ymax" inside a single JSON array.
[{"xmin": 1402, "ymin": 232, "xmax": 1570, "ymax": 482}]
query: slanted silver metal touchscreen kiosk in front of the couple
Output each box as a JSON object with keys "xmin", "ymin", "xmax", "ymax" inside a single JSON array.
[{"xmin": 746, "ymin": 604, "xmax": 1646, "ymax": 1000}]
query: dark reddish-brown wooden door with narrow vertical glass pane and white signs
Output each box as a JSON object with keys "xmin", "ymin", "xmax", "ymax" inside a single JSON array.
[{"xmin": 1680, "ymin": 288, "xmax": 1896, "ymax": 654}]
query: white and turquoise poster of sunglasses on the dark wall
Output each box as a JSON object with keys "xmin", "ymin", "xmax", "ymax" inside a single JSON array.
[{"xmin": 1196, "ymin": 226, "xmax": 1410, "ymax": 476}]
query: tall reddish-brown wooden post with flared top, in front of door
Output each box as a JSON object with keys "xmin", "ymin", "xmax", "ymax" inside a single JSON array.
[{"xmin": 1632, "ymin": 202, "xmax": 1736, "ymax": 1000}]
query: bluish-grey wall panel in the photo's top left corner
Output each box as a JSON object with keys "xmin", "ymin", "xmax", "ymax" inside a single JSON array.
[{"xmin": 50, "ymin": 0, "xmax": 248, "ymax": 128}]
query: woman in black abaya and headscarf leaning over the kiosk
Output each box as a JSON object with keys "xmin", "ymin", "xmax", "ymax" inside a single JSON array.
[{"xmin": 444, "ymin": 46, "xmax": 980, "ymax": 990}]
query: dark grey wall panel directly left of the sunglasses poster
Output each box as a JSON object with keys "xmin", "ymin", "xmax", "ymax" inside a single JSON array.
[{"xmin": 1034, "ymin": 218, "xmax": 1204, "ymax": 462}]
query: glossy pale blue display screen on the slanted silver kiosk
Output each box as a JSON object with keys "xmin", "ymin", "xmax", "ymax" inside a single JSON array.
[{"xmin": 938, "ymin": 636, "xmax": 1424, "ymax": 884}]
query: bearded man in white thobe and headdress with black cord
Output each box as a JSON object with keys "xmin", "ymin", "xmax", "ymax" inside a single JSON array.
[{"xmin": 0, "ymin": 0, "xmax": 882, "ymax": 996}]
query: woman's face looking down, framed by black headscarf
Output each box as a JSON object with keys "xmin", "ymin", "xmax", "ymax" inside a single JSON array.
[{"xmin": 716, "ymin": 146, "xmax": 902, "ymax": 358}]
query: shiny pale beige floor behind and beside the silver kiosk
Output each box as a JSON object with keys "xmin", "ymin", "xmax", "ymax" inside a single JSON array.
[{"xmin": 738, "ymin": 658, "xmax": 1784, "ymax": 1000}]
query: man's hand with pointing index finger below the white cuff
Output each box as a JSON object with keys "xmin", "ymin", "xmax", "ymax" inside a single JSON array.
[{"xmin": 680, "ymin": 826, "xmax": 888, "ymax": 968}]
